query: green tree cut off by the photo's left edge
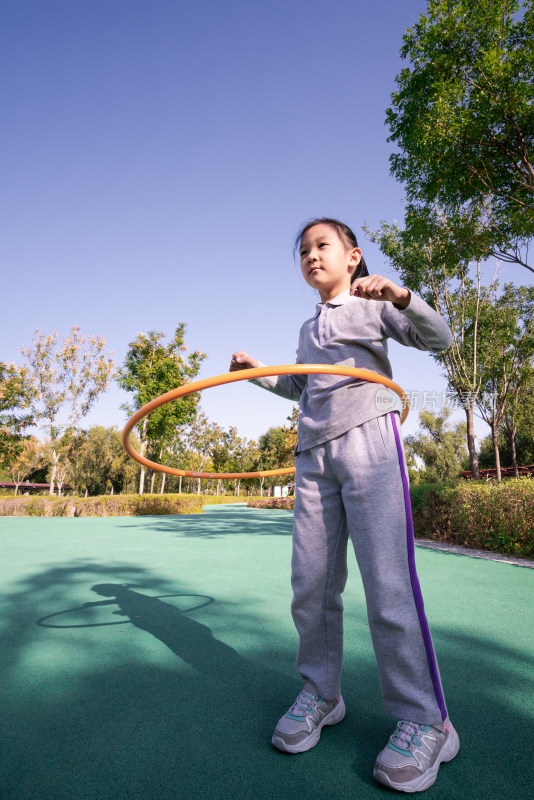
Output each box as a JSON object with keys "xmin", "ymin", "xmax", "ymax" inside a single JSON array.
[{"xmin": 0, "ymin": 362, "xmax": 34, "ymax": 466}]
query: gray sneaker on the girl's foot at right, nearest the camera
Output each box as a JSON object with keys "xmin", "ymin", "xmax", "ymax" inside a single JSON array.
[{"xmin": 373, "ymin": 719, "xmax": 460, "ymax": 792}]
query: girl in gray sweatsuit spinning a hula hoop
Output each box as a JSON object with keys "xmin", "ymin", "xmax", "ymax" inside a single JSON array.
[{"xmin": 230, "ymin": 218, "xmax": 459, "ymax": 792}]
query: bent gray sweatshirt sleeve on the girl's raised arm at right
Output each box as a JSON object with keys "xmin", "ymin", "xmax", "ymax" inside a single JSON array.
[{"xmin": 382, "ymin": 292, "xmax": 452, "ymax": 353}]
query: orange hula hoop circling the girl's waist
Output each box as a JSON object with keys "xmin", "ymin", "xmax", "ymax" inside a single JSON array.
[{"xmin": 122, "ymin": 364, "xmax": 410, "ymax": 480}]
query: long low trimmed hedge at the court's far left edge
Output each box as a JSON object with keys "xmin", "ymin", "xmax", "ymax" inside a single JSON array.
[{"xmin": 0, "ymin": 494, "xmax": 205, "ymax": 517}]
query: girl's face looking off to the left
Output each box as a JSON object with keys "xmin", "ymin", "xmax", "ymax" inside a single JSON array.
[{"xmin": 300, "ymin": 223, "xmax": 362, "ymax": 303}]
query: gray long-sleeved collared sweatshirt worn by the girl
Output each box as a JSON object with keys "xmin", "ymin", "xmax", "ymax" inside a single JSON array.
[{"xmin": 251, "ymin": 290, "xmax": 452, "ymax": 452}]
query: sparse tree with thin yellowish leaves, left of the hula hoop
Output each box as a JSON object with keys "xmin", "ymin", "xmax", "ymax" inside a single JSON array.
[{"xmin": 22, "ymin": 325, "xmax": 114, "ymax": 494}]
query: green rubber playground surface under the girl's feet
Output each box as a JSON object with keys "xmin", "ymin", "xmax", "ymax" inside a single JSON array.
[{"xmin": 0, "ymin": 506, "xmax": 534, "ymax": 800}]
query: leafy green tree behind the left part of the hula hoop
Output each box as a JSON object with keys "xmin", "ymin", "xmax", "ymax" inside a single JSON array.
[{"xmin": 117, "ymin": 323, "xmax": 206, "ymax": 494}]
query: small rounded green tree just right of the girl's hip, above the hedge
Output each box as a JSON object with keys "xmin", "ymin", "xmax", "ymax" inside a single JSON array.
[{"xmin": 405, "ymin": 408, "xmax": 468, "ymax": 483}]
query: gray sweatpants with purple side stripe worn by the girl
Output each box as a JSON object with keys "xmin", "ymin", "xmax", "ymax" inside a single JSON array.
[{"xmin": 292, "ymin": 412, "xmax": 447, "ymax": 725}]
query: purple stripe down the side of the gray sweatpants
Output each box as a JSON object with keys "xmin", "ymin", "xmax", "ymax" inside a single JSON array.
[{"xmin": 389, "ymin": 412, "xmax": 447, "ymax": 719}]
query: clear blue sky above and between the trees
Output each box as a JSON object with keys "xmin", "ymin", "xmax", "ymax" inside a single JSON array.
[{"xmin": 0, "ymin": 0, "xmax": 528, "ymax": 444}]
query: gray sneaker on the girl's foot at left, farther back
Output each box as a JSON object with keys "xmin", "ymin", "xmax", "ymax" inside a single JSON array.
[{"xmin": 272, "ymin": 689, "xmax": 345, "ymax": 753}]
